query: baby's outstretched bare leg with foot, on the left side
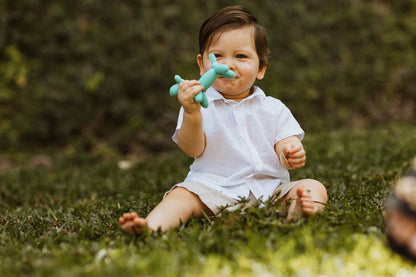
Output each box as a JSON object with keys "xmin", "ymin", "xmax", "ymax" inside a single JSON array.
[{"xmin": 119, "ymin": 187, "xmax": 212, "ymax": 235}]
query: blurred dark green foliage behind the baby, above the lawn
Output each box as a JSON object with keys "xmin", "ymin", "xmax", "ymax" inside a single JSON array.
[{"xmin": 0, "ymin": 0, "xmax": 416, "ymax": 152}]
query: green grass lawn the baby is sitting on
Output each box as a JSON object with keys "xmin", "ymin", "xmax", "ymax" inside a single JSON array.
[{"xmin": 0, "ymin": 126, "xmax": 416, "ymax": 276}]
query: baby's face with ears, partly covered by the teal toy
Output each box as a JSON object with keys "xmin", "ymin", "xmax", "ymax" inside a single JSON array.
[{"xmin": 198, "ymin": 26, "xmax": 266, "ymax": 101}]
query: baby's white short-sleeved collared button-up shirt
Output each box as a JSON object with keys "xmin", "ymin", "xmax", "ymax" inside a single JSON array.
[{"xmin": 172, "ymin": 87, "xmax": 304, "ymax": 200}]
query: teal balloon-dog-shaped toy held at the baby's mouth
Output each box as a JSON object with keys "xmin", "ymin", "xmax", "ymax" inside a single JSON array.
[{"xmin": 169, "ymin": 53, "xmax": 235, "ymax": 108}]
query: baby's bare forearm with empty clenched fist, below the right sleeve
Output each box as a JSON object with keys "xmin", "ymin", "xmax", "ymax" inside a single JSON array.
[{"xmin": 274, "ymin": 136, "xmax": 306, "ymax": 169}]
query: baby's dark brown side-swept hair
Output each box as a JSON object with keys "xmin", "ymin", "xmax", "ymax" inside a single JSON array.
[{"xmin": 199, "ymin": 6, "xmax": 269, "ymax": 69}]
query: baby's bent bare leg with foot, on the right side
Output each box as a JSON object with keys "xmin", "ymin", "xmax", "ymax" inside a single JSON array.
[{"xmin": 284, "ymin": 179, "xmax": 328, "ymax": 221}]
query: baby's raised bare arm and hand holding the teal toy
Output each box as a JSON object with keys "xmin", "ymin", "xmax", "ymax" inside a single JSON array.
[{"xmin": 177, "ymin": 80, "xmax": 205, "ymax": 157}]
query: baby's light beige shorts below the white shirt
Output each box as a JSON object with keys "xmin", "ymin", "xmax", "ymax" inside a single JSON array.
[{"xmin": 165, "ymin": 181, "xmax": 300, "ymax": 215}]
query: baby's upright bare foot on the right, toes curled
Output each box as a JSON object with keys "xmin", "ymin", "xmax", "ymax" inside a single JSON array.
[{"xmin": 286, "ymin": 187, "xmax": 324, "ymax": 221}]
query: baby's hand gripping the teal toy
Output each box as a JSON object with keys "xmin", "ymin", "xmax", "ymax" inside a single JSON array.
[{"xmin": 178, "ymin": 80, "xmax": 204, "ymax": 114}]
